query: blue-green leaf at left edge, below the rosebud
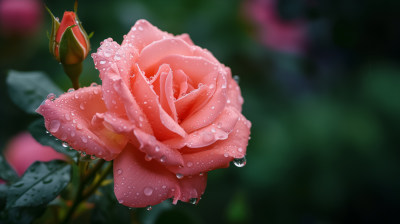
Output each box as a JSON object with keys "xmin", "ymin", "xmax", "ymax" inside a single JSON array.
[{"xmin": 7, "ymin": 71, "xmax": 63, "ymax": 114}]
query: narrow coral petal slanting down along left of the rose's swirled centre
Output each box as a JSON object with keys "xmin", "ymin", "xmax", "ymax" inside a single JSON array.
[{"xmin": 132, "ymin": 63, "xmax": 186, "ymax": 140}]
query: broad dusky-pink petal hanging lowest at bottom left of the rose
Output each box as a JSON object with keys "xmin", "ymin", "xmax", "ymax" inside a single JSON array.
[{"xmin": 114, "ymin": 145, "xmax": 179, "ymax": 207}]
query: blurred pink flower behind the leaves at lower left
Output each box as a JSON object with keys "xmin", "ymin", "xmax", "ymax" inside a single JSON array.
[{"xmin": 3, "ymin": 132, "xmax": 66, "ymax": 176}]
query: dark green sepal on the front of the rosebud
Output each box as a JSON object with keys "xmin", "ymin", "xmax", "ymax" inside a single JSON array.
[{"xmin": 59, "ymin": 25, "xmax": 86, "ymax": 65}]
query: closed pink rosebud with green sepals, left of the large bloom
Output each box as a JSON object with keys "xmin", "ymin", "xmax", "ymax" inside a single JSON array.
[{"xmin": 47, "ymin": 6, "xmax": 90, "ymax": 89}]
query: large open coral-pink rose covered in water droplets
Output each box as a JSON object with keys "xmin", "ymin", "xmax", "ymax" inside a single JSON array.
[{"xmin": 37, "ymin": 20, "xmax": 251, "ymax": 207}]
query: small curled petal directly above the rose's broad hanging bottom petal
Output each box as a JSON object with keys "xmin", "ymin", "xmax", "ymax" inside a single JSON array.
[{"xmin": 133, "ymin": 129, "xmax": 183, "ymax": 165}]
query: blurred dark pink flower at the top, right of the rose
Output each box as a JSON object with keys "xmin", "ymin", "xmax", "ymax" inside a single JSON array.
[{"xmin": 244, "ymin": 0, "xmax": 307, "ymax": 54}]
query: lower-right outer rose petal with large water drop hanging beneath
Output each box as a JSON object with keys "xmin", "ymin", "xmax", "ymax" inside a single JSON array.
[{"xmin": 168, "ymin": 115, "xmax": 251, "ymax": 176}]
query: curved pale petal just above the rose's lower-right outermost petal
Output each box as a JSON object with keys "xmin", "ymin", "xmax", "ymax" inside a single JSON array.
[{"xmin": 163, "ymin": 107, "xmax": 240, "ymax": 149}]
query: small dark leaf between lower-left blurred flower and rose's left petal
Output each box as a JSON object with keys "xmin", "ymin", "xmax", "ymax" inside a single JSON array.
[{"xmin": 28, "ymin": 117, "xmax": 77, "ymax": 157}]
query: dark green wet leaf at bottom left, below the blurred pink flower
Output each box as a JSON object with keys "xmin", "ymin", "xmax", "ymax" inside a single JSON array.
[{"xmin": 6, "ymin": 160, "xmax": 71, "ymax": 209}]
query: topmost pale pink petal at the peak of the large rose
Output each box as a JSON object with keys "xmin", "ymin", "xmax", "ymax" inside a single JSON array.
[{"xmin": 122, "ymin": 19, "xmax": 173, "ymax": 53}]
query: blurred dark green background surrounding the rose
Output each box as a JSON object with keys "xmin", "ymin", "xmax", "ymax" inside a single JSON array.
[{"xmin": 0, "ymin": 0, "xmax": 400, "ymax": 224}]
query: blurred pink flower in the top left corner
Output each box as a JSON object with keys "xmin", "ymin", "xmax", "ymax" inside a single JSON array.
[{"xmin": 0, "ymin": 0, "xmax": 43, "ymax": 36}]
